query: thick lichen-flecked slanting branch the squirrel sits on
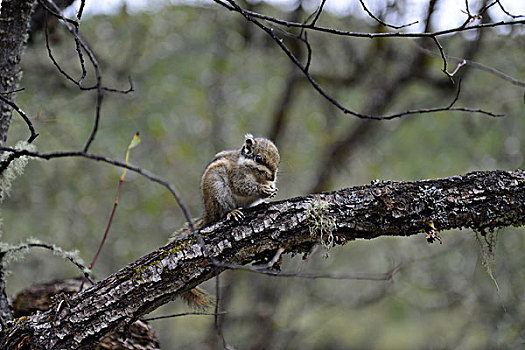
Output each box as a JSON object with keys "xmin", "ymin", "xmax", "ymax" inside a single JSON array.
[{"xmin": 0, "ymin": 170, "xmax": 525, "ymax": 349}]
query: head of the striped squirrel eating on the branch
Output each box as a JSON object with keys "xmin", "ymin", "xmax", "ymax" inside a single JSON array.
[{"xmin": 241, "ymin": 134, "xmax": 281, "ymax": 182}]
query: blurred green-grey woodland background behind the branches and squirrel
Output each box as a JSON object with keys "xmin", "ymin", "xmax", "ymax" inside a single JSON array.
[{"xmin": 2, "ymin": 0, "xmax": 525, "ymax": 349}]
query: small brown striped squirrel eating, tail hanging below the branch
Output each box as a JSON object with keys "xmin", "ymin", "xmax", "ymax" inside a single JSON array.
[{"xmin": 175, "ymin": 134, "xmax": 281, "ymax": 308}]
